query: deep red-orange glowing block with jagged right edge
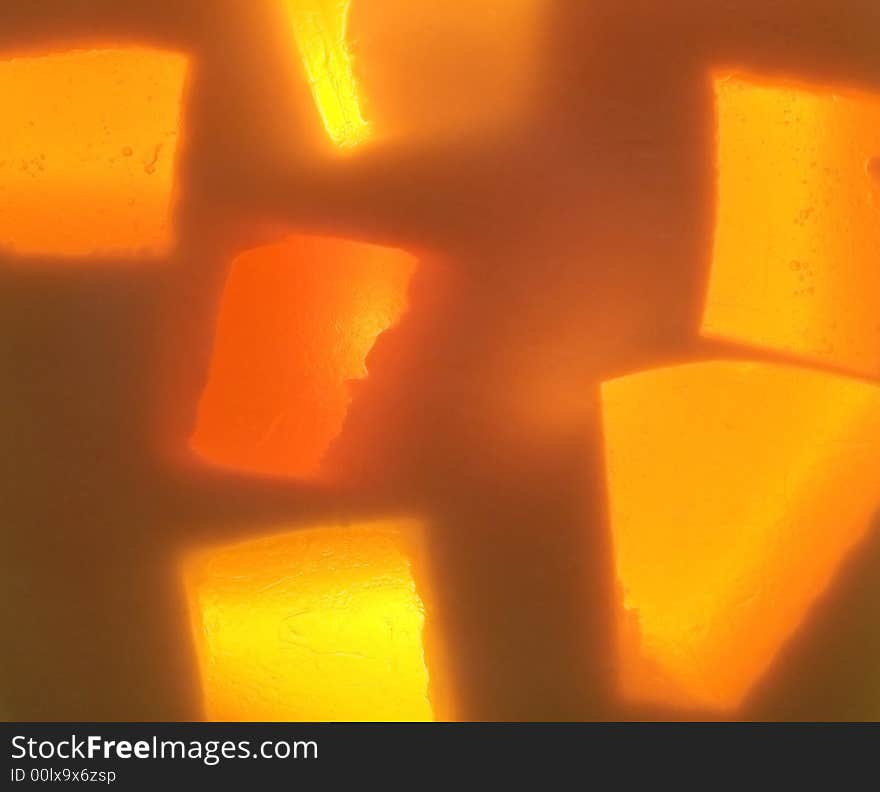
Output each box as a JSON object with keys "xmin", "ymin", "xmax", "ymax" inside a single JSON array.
[{"xmin": 191, "ymin": 236, "xmax": 415, "ymax": 476}]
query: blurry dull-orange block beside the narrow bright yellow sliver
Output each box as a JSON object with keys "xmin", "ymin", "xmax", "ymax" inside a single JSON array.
[{"xmin": 348, "ymin": 0, "xmax": 540, "ymax": 143}]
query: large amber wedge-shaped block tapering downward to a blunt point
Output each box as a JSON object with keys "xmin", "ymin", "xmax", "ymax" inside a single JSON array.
[{"xmin": 602, "ymin": 362, "xmax": 880, "ymax": 709}]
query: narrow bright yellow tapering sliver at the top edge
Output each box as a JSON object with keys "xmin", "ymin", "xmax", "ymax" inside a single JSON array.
[{"xmin": 288, "ymin": 0, "xmax": 370, "ymax": 146}]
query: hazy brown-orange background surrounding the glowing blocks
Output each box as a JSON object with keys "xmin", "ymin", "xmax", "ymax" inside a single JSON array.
[{"xmin": 0, "ymin": 0, "xmax": 880, "ymax": 720}]
